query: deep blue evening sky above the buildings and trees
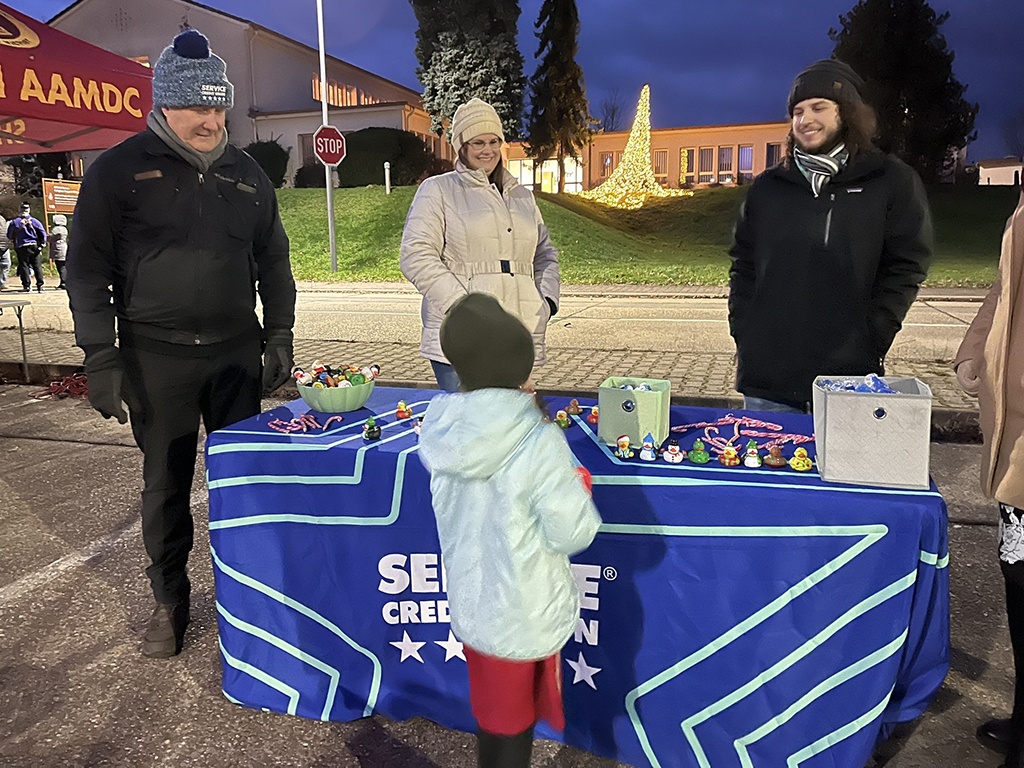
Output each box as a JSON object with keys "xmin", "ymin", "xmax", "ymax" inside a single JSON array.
[{"xmin": 4, "ymin": 0, "xmax": 1024, "ymax": 161}]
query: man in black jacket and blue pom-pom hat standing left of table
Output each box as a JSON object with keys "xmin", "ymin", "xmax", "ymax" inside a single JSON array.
[{"xmin": 68, "ymin": 29, "xmax": 295, "ymax": 658}]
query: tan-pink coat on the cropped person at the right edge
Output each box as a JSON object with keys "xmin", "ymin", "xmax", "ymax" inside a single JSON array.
[{"xmin": 953, "ymin": 189, "xmax": 1024, "ymax": 509}]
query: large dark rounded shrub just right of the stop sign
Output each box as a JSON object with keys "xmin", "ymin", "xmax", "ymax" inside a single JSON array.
[{"xmin": 338, "ymin": 128, "xmax": 436, "ymax": 186}]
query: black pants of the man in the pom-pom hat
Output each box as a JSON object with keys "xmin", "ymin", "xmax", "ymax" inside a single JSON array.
[{"xmin": 121, "ymin": 336, "xmax": 261, "ymax": 603}]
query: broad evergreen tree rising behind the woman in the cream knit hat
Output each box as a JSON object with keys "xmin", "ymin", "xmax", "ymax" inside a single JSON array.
[{"xmin": 410, "ymin": 0, "xmax": 525, "ymax": 139}]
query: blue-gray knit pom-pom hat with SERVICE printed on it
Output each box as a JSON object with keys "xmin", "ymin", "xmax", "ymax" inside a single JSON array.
[{"xmin": 153, "ymin": 30, "xmax": 234, "ymax": 110}]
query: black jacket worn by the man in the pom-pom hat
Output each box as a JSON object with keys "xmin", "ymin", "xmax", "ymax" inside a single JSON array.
[{"xmin": 68, "ymin": 130, "xmax": 295, "ymax": 353}]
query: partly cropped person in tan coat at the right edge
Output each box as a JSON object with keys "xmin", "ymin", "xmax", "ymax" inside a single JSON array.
[{"xmin": 953, "ymin": 188, "xmax": 1024, "ymax": 768}]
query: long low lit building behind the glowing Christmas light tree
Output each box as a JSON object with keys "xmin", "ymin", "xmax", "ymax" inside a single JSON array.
[{"xmin": 508, "ymin": 121, "xmax": 790, "ymax": 191}]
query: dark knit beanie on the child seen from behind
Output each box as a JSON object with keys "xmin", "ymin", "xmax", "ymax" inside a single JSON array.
[{"xmin": 440, "ymin": 293, "xmax": 534, "ymax": 392}]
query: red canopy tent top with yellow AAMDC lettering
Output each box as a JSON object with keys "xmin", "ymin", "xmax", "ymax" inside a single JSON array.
[{"xmin": 0, "ymin": 3, "xmax": 153, "ymax": 156}]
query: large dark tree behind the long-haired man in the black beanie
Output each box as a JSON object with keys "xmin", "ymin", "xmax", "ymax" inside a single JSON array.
[{"xmin": 828, "ymin": 0, "xmax": 978, "ymax": 181}]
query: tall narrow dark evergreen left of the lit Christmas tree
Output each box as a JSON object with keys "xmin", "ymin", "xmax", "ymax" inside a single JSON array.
[{"xmin": 526, "ymin": 0, "xmax": 594, "ymax": 194}]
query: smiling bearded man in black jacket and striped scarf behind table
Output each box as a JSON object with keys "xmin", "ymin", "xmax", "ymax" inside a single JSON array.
[{"xmin": 729, "ymin": 59, "xmax": 932, "ymax": 412}]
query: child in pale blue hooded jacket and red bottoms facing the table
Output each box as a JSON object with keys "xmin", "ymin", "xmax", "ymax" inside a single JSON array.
[{"xmin": 420, "ymin": 293, "xmax": 601, "ymax": 768}]
